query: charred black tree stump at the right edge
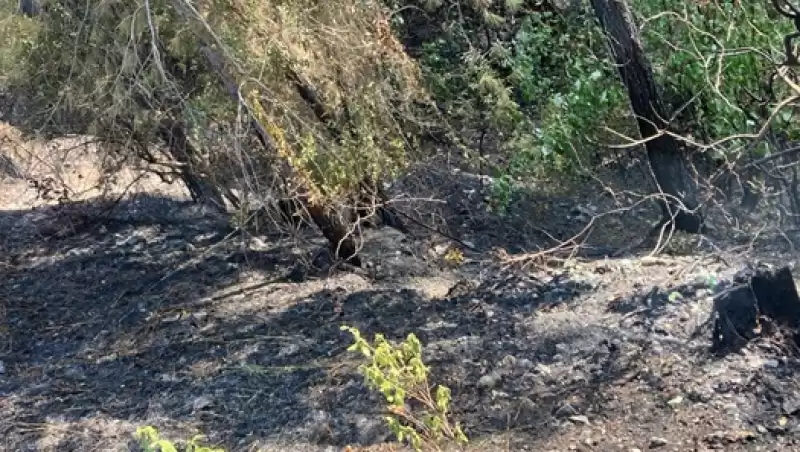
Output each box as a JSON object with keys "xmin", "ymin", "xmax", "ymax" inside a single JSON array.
[{"xmin": 712, "ymin": 264, "xmax": 800, "ymax": 352}]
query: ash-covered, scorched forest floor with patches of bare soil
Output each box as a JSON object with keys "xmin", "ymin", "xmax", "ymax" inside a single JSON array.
[{"xmin": 0, "ymin": 124, "xmax": 800, "ymax": 452}]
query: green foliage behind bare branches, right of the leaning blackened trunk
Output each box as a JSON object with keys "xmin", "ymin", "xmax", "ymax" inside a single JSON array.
[{"xmin": 633, "ymin": 0, "xmax": 800, "ymax": 152}]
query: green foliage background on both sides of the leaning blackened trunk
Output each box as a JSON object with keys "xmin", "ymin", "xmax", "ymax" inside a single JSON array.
[{"xmin": 401, "ymin": 0, "xmax": 800, "ymax": 212}]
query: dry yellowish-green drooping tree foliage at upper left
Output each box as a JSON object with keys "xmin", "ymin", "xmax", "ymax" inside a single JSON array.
[{"xmin": 0, "ymin": 0, "xmax": 424, "ymax": 208}]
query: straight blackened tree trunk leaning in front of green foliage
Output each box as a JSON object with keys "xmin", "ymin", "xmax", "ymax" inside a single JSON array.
[{"xmin": 591, "ymin": 0, "xmax": 705, "ymax": 233}]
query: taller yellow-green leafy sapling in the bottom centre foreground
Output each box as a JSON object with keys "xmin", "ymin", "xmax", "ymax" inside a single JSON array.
[{"xmin": 341, "ymin": 326, "xmax": 467, "ymax": 451}]
